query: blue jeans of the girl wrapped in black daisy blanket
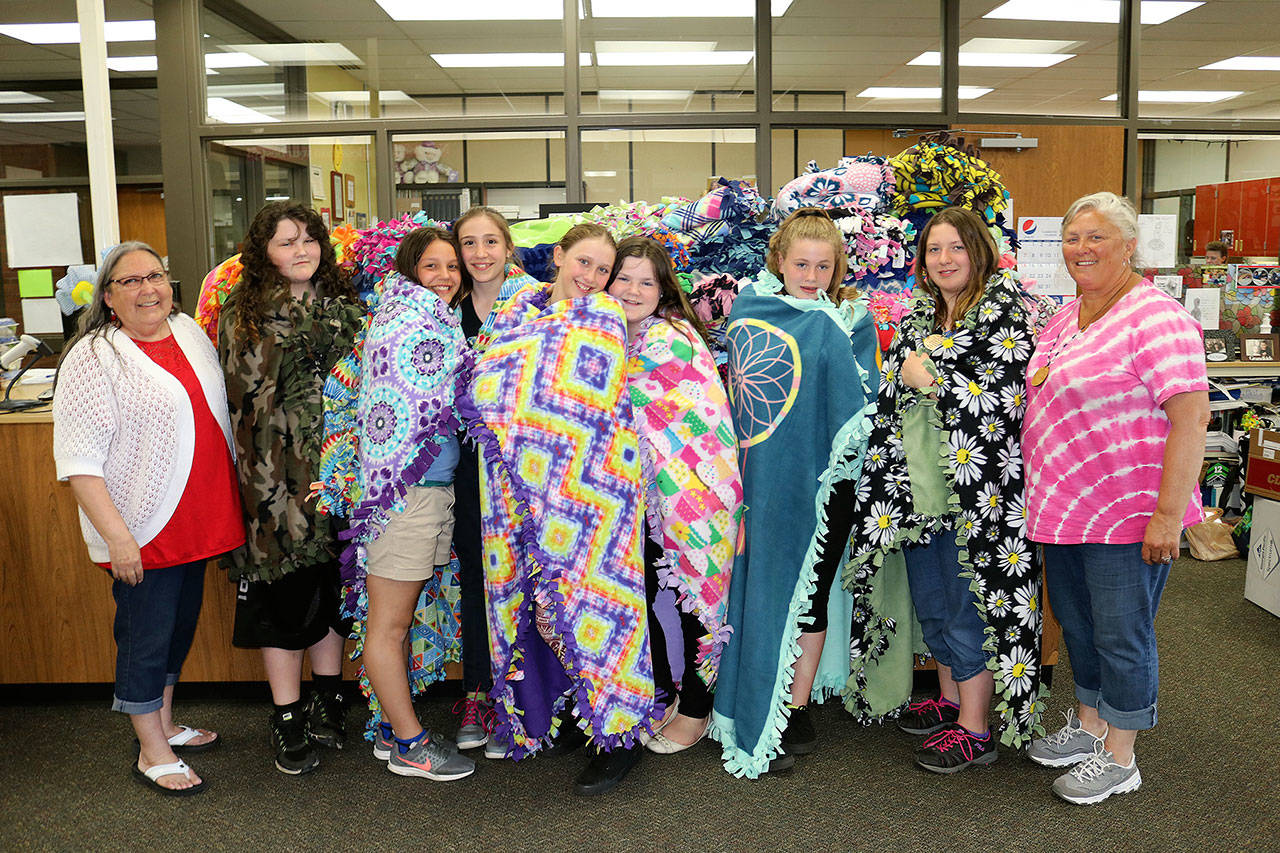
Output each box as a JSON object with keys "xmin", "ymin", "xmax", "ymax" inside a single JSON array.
[{"xmin": 902, "ymin": 530, "xmax": 987, "ymax": 681}]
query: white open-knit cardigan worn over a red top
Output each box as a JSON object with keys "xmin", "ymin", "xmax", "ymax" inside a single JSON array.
[{"xmin": 54, "ymin": 314, "xmax": 236, "ymax": 562}]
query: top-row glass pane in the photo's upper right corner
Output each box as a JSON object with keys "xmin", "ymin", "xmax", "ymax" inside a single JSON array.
[{"xmin": 1138, "ymin": 0, "xmax": 1280, "ymax": 117}]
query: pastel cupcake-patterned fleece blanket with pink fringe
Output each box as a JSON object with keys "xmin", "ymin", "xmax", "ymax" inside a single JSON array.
[{"xmin": 628, "ymin": 318, "xmax": 742, "ymax": 686}]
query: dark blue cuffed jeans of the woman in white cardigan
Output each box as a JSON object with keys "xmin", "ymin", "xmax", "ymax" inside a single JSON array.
[{"xmin": 111, "ymin": 560, "xmax": 207, "ymax": 713}]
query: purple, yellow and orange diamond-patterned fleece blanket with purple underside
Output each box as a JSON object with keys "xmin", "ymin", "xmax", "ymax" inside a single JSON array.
[{"xmin": 460, "ymin": 284, "xmax": 654, "ymax": 760}]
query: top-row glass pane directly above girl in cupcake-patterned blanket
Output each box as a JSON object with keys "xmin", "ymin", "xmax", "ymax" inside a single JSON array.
[{"xmin": 579, "ymin": 6, "xmax": 755, "ymax": 113}]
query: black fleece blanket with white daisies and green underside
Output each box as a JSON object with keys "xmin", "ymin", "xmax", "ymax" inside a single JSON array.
[{"xmin": 845, "ymin": 270, "xmax": 1047, "ymax": 747}]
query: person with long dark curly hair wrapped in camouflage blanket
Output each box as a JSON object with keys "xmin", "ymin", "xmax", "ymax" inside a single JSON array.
[{"xmin": 218, "ymin": 201, "xmax": 364, "ymax": 775}]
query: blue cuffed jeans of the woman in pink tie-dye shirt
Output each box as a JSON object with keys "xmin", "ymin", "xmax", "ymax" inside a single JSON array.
[{"xmin": 1044, "ymin": 542, "xmax": 1169, "ymax": 730}]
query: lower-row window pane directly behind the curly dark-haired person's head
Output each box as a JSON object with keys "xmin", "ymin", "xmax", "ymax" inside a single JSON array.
[{"xmin": 205, "ymin": 136, "xmax": 378, "ymax": 263}]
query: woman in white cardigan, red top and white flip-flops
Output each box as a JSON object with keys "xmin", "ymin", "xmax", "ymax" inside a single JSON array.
[{"xmin": 54, "ymin": 242, "xmax": 244, "ymax": 795}]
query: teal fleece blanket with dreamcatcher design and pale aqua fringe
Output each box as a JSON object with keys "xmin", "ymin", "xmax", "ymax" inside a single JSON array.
[{"xmin": 712, "ymin": 272, "xmax": 877, "ymax": 779}]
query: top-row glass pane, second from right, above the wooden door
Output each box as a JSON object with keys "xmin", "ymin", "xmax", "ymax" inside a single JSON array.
[{"xmin": 962, "ymin": 0, "xmax": 1121, "ymax": 117}]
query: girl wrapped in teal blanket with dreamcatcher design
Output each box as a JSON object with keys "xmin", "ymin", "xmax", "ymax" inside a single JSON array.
[{"xmin": 712, "ymin": 207, "xmax": 877, "ymax": 779}]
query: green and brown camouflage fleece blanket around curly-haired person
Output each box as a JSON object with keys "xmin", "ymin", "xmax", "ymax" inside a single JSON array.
[{"xmin": 218, "ymin": 285, "xmax": 364, "ymax": 580}]
